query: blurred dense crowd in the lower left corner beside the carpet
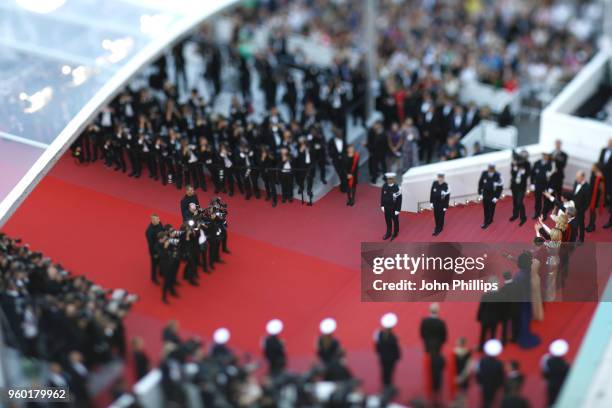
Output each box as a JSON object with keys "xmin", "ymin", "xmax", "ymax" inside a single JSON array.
[{"xmin": 0, "ymin": 233, "xmax": 137, "ymax": 407}]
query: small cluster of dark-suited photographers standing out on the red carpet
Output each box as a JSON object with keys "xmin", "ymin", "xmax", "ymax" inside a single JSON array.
[{"xmin": 145, "ymin": 191, "xmax": 230, "ymax": 304}]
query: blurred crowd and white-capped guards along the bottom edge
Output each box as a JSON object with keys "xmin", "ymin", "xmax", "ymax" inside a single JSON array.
[{"xmin": 123, "ymin": 294, "xmax": 569, "ymax": 408}]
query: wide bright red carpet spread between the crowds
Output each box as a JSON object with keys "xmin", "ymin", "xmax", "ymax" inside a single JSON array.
[{"xmin": 4, "ymin": 157, "xmax": 611, "ymax": 406}]
